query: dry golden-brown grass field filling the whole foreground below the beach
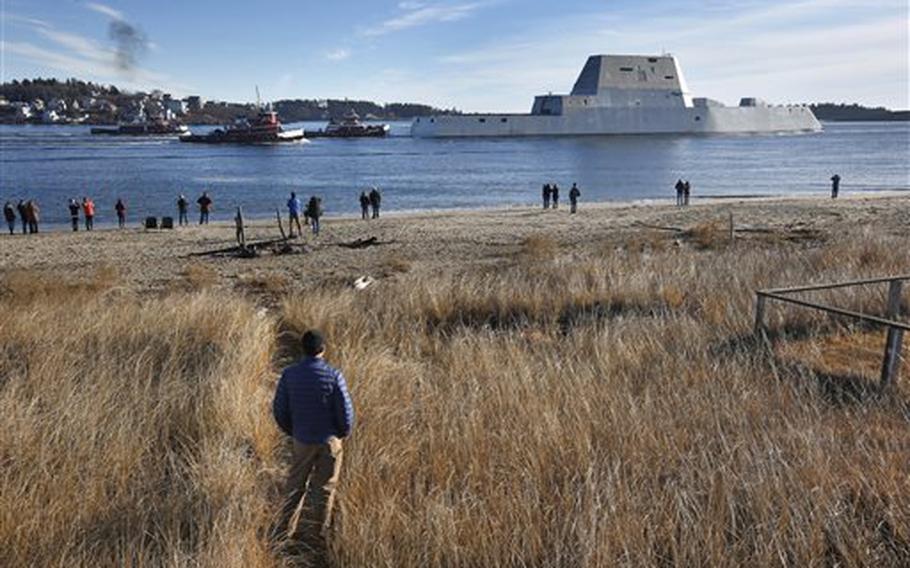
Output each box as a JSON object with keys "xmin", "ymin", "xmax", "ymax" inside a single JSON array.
[{"xmin": 0, "ymin": 197, "xmax": 910, "ymax": 567}]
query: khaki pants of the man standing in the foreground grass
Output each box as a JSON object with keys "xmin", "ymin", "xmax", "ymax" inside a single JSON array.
[{"xmin": 281, "ymin": 436, "xmax": 342, "ymax": 549}]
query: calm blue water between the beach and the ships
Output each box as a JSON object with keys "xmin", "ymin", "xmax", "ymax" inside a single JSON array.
[{"xmin": 0, "ymin": 122, "xmax": 910, "ymax": 224}]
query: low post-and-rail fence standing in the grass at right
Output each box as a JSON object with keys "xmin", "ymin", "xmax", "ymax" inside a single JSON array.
[{"xmin": 755, "ymin": 275, "xmax": 910, "ymax": 389}]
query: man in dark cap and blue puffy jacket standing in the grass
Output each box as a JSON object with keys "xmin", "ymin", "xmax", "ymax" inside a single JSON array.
[{"xmin": 272, "ymin": 330, "xmax": 354, "ymax": 550}]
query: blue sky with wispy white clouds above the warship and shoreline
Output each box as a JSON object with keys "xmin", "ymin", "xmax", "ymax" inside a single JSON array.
[{"xmin": 0, "ymin": 0, "xmax": 910, "ymax": 112}]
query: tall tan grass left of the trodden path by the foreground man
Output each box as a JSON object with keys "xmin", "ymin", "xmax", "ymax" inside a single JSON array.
[{"xmin": 0, "ymin": 275, "xmax": 278, "ymax": 566}]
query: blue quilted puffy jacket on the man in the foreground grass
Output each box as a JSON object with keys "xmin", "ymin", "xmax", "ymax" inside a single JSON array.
[{"xmin": 272, "ymin": 357, "xmax": 354, "ymax": 444}]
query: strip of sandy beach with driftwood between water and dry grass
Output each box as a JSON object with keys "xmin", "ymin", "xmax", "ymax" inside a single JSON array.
[{"xmin": 0, "ymin": 192, "xmax": 910, "ymax": 291}]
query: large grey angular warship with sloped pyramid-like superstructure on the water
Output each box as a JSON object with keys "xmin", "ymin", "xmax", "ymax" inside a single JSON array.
[{"xmin": 411, "ymin": 55, "xmax": 821, "ymax": 137}]
